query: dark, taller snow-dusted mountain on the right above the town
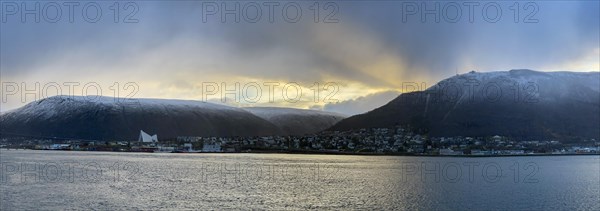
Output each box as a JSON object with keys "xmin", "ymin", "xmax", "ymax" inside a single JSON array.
[{"xmin": 329, "ymin": 69, "xmax": 600, "ymax": 139}]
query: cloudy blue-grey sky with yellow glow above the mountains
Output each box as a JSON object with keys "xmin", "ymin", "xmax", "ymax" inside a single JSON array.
[{"xmin": 0, "ymin": 1, "xmax": 600, "ymax": 115}]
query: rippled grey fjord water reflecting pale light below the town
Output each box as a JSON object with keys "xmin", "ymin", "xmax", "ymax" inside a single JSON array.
[{"xmin": 0, "ymin": 150, "xmax": 600, "ymax": 210}]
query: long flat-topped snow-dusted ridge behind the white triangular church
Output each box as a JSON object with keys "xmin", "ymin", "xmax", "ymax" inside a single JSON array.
[{"xmin": 0, "ymin": 96, "xmax": 341, "ymax": 140}]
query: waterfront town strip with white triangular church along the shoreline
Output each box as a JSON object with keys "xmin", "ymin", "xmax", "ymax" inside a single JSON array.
[{"xmin": 0, "ymin": 127, "xmax": 600, "ymax": 156}]
